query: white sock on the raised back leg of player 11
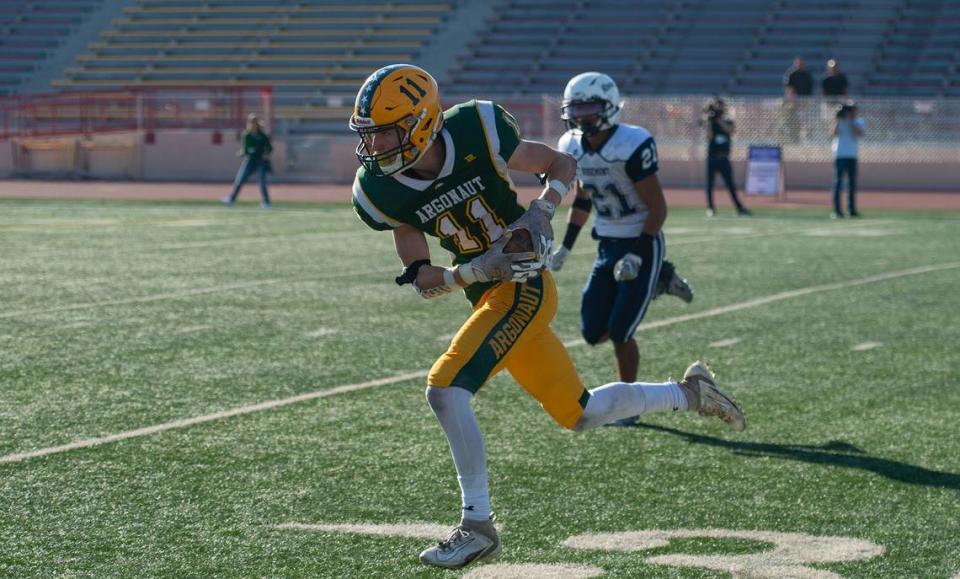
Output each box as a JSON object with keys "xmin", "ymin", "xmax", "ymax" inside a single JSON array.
[{"xmin": 574, "ymin": 382, "xmax": 687, "ymax": 431}]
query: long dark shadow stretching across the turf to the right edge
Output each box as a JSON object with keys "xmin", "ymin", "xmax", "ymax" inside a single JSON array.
[{"xmin": 620, "ymin": 422, "xmax": 960, "ymax": 489}]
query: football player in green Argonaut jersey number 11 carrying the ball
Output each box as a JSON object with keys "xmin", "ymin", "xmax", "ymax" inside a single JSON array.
[{"xmin": 350, "ymin": 64, "xmax": 745, "ymax": 568}]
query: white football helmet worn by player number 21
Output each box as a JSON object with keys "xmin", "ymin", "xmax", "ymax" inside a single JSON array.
[{"xmin": 560, "ymin": 72, "xmax": 623, "ymax": 137}]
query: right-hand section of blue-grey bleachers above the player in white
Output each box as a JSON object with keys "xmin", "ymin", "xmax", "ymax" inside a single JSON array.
[{"xmin": 454, "ymin": 0, "xmax": 928, "ymax": 95}]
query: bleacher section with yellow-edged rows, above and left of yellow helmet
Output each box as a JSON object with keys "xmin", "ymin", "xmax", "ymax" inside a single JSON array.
[{"xmin": 54, "ymin": 0, "xmax": 451, "ymax": 92}]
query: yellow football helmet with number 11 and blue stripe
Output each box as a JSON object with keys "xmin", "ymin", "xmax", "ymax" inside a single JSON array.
[{"xmin": 350, "ymin": 64, "xmax": 443, "ymax": 176}]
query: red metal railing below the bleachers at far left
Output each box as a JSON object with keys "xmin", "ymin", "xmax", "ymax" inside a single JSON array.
[{"xmin": 0, "ymin": 86, "xmax": 273, "ymax": 140}]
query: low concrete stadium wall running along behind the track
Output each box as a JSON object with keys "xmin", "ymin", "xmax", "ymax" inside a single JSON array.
[{"xmin": 0, "ymin": 130, "xmax": 960, "ymax": 194}]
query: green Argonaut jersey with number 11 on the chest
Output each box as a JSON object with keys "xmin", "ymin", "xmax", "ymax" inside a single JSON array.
[{"xmin": 353, "ymin": 100, "xmax": 524, "ymax": 303}]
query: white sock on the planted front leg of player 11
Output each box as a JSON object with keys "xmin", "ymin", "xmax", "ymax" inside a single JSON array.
[{"xmin": 427, "ymin": 386, "xmax": 490, "ymax": 521}]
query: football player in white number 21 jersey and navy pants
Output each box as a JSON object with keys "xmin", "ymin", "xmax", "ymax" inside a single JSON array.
[{"xmin": 550, "ymin": 72, "xmax": 693, "ymax": 423}]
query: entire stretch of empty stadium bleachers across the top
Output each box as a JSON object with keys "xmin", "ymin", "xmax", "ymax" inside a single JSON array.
[{"xmin": 0, "ymin": 0, "xmax": 960, "ymax": 133}]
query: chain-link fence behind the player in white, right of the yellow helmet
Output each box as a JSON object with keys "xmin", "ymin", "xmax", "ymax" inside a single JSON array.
[{"xmin": 484, "ymin": 97, "xmax": 960, "ymax": 164}]
